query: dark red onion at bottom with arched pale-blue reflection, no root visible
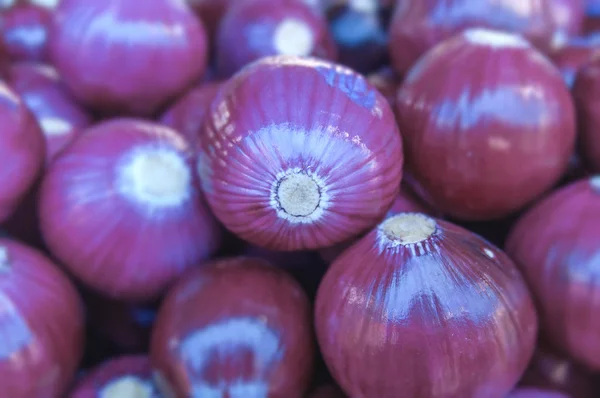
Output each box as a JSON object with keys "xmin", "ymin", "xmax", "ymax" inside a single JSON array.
[{"xmin": 151, "ymin": 257, "xmax": 314, "ymax": 398}]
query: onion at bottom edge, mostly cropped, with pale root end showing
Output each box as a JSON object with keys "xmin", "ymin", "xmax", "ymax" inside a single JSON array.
[{"xmin": 69, "ymin": 355, "xmax": 162, "ymax": 398}]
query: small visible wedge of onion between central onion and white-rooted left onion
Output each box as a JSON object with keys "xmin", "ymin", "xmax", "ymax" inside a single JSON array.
[{"xmin": 160, "ymin": 82, "xmax": 221, "ymax": 145}]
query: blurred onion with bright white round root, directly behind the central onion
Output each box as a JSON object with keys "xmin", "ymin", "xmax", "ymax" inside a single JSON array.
[{"xmin": 216, "ymin": 0, "xmax": 337, "ymax": 77}]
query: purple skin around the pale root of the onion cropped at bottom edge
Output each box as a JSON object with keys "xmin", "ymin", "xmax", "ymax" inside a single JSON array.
[{"xmin": 69, "ymin": 355, "xmax": 162, "ymax": 398}]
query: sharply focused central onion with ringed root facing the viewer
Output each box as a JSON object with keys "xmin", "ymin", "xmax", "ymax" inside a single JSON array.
[{"xmin": 198, "ymin": 56, "xmax": 403, "ymax": 250}]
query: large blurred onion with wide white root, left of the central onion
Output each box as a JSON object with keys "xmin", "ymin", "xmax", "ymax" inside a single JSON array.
[{"xmin": 40, "ymin": 119, "xmax": 223, "ymax": 301}]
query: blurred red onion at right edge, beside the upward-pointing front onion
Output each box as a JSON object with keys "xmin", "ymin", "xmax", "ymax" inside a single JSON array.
[{"xmin": 506, "ymin": 177, "xmax": 600, "ymax": 370}]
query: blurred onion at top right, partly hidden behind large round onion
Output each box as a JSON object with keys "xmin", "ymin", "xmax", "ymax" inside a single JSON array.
[{"xmin": 390, "ymin": 0, "xmax": 555, "ymax": 74}]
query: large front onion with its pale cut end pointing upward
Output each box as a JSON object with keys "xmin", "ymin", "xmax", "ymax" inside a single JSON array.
[{"xmin": 315, "ymin": 213, "xmax": 537, "ymax": 398}]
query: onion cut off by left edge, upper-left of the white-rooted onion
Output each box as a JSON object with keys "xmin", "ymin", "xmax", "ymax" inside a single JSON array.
[{"xmin": 0, "ymin": 81, "xmax": 46, "ymax": 222}]
